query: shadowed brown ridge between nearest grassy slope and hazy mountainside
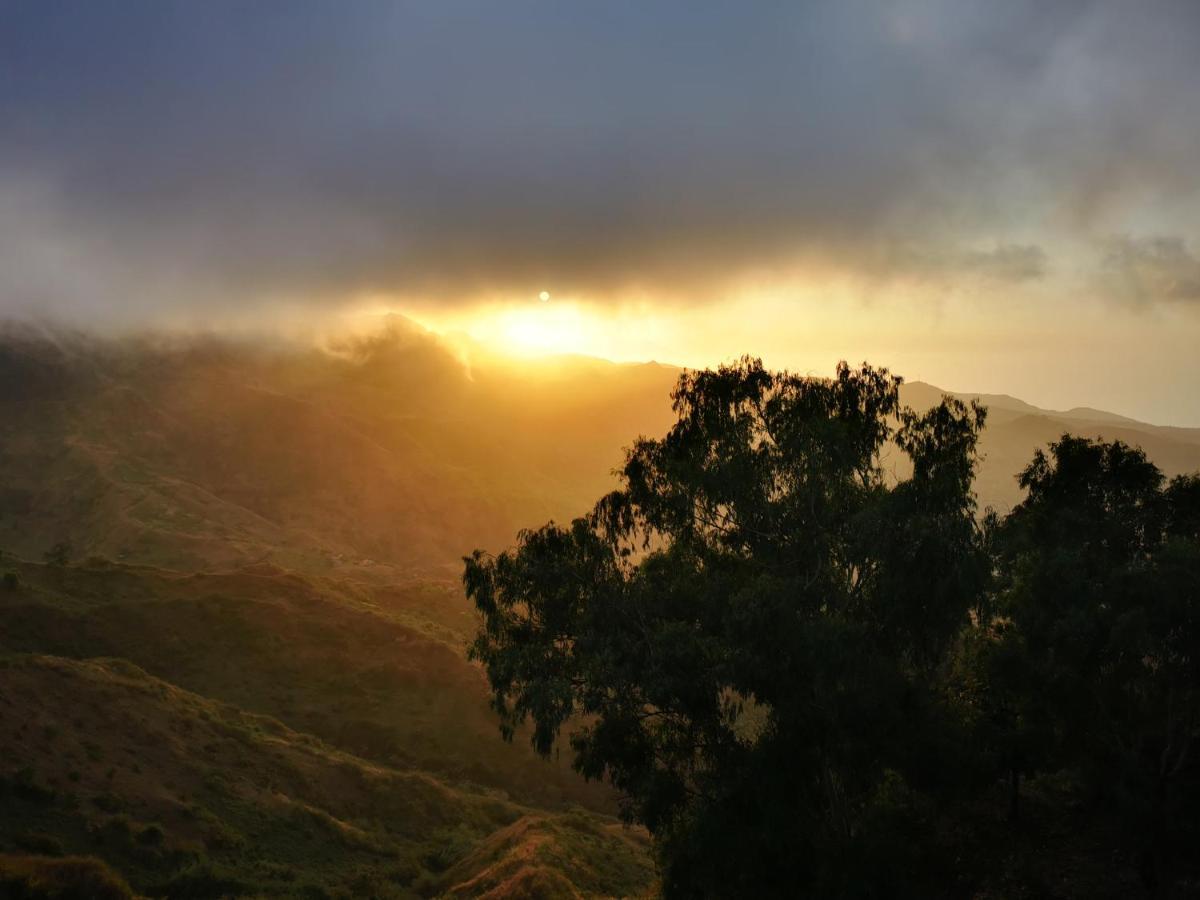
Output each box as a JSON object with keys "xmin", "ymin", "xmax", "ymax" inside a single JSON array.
[{"xmin": 0, "ymin": 565, "xmax": 614, "ymax": 812}]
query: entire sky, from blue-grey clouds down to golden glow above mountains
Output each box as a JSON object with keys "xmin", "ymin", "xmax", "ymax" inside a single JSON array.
[{"xmin": 0, "ymin": 0, "xmax": 1200, "ymax": 425}]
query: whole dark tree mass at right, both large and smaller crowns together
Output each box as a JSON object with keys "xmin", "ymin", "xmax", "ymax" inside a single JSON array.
[{"xmin": 463, "ymin": 359, "xmax": 1200, "ymax": 896}]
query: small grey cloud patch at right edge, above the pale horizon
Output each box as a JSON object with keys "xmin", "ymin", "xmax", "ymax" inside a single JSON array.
[{"xmin": 1102, "ymin": 236, "xmax": 1200, "ymax": 304}]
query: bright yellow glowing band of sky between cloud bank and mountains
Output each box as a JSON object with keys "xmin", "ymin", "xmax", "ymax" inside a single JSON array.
[{"xmin": 350, "ymin": 277, "xmax": 1171, "ymax": 422}]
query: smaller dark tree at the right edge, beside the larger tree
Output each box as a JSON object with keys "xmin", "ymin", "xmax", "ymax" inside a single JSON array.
[{"xmin": 992, "ymin": 436, "xmax": 1200, "ymax": 889}]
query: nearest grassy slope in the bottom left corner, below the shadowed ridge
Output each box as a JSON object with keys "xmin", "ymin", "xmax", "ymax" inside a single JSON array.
[{"xmin": 0, "ymin": 655, "xmax": 653, "ymax": 896}]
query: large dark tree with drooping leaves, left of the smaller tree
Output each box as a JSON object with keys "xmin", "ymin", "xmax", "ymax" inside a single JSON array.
[{"xmin": 463, "ymin": 359, "xmax": 988, "ymax": 896}]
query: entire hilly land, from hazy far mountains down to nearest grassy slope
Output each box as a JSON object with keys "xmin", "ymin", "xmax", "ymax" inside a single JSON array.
[{"xmin": 0, "ymin": 318, "xmax": 1200, "ymax": 896}]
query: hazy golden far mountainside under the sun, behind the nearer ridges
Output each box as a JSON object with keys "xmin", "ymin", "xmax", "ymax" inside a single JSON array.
[{"xmin": 0, "ymin": 317, "xmax": 1200, "ymax": 580}]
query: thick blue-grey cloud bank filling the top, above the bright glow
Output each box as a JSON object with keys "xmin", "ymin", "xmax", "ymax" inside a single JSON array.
[{"xmin": 0, "ymin": 0, "xmax": 1200, "ymax": 319}]
